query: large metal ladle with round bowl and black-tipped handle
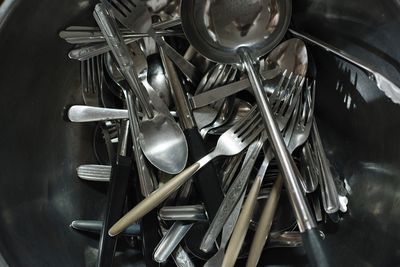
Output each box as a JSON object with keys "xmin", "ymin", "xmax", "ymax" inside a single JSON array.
[{"xmin": 181, "ymin": 0, "xmax": 328, "ymax": 266}]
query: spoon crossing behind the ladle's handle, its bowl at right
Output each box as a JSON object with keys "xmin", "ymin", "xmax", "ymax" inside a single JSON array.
[{"xmin": 191, "ymin": 39, "xmax": 308, "ymax": 108}]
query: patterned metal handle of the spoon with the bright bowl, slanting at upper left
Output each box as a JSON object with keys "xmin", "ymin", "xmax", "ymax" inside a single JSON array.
[{"xmin": 93, "ymin": 4, "xmax": 154, "ymax": 118}]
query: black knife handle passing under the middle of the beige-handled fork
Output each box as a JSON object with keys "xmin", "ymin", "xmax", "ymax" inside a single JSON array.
[{"xmin": 184, "ymin": 128, "xmax": 223, "ymax": 221}]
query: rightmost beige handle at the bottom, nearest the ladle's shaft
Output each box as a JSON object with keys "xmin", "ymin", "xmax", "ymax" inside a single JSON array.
[{"xmin": 246, "ymin": 174, "xmax": 282, "ymax": 267}]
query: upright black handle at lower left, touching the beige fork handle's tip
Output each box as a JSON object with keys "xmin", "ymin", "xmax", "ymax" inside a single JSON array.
[{"xmin": 97, "ymin": 156, "xmax": 132, "ymax": 267}]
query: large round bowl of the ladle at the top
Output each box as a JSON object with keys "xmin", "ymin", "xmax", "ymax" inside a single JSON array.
[{"xmin": 181, "ymin": 0, "xmax": 291, "ymax": 63}]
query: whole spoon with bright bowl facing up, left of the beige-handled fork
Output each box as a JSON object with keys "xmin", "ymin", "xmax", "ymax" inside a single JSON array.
[{"xmin": 94, "ymin": 4, "xmax": 188, "ymax": 174}]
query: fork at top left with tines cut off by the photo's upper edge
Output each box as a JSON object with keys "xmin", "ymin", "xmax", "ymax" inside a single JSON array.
[{"xmin": 101, "ymin": 0, "xmax": 199, "ymax": 84}]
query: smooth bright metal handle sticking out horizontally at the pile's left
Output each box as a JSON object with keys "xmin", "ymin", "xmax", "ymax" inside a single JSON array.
[{"xmin": 68, "ymin": 105, "xmax": 128, "ymax": 122}]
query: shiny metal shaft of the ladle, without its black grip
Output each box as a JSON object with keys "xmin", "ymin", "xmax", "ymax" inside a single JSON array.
[{"xmin": 239, "ymin": 48, "xmax": 316, "ymax": 232}]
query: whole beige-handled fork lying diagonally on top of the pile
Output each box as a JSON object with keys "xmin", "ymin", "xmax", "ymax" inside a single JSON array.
[{"xmin": 108, "ymin": 107, "xmax": 263, "ymax": 236}]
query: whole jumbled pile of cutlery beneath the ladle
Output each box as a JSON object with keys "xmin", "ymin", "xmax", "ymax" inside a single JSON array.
[{"xmin": 54, "ymin": 0, "xmax": 398, "ymax": 266}]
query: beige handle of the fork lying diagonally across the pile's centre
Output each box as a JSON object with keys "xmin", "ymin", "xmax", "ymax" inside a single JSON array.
[{"xmin": 108, "ymin": 162, "xmax": 201, "ymax": 236}]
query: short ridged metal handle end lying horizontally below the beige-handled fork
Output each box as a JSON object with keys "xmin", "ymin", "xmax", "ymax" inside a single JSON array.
[{"xmin": 158, "ymin": 205, "xmax": 208, "ymax": 222}]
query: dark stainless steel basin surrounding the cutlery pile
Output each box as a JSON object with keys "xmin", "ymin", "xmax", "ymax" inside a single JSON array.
[{"xmin": 0, "ymin": 0, "xmax": 400, "ymax": 267}]
